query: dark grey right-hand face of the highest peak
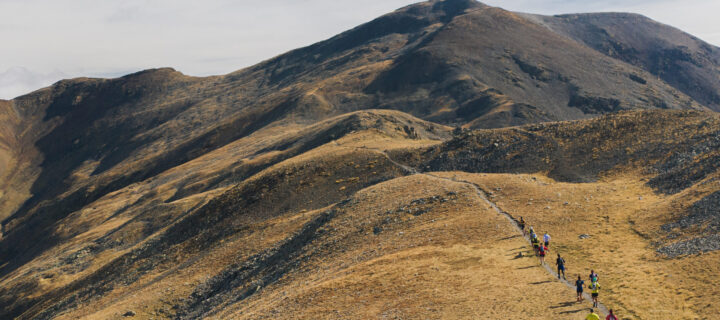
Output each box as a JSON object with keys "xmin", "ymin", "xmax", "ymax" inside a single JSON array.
[{"xmin": 369, "ymin": 7, "xmax": 697, "ymax": 127}]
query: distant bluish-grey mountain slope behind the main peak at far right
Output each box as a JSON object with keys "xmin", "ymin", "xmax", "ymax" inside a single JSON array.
[{"xmin": 531, "ymin": 13, "xmax": 720, "ymax": 111}]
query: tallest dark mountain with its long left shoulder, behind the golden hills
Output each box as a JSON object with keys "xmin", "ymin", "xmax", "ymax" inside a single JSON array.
[{"xmin": 1, "ymin": 0, "xmax": 716, "ymax": 232}]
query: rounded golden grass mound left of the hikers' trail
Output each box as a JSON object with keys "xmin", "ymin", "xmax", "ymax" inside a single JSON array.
[{"xmin": 215, "ymin": 175, "xmax": 600, "ymax": 319}]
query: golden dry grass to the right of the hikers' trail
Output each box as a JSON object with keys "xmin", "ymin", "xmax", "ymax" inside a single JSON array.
[{"xmin": 434, "ymin": 173, "xmax": 720, "ymax": 319}]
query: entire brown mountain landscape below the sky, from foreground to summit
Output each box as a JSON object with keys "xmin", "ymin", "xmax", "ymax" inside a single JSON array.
[{"xmin": 0, "ymin": 0, "xmax": 720, "ymax": 319}]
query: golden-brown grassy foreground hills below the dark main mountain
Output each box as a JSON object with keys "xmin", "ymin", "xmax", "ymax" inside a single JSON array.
[{"xmin": 2, "ymin": 111, "xmax": 720, "ymax": 319}]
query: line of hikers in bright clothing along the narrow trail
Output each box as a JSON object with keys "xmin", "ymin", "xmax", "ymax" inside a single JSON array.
[{"xmin": 518, "ymin": 217, "xmax": 618, "ymax": 320}]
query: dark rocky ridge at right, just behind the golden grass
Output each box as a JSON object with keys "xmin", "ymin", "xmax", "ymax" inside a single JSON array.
[{"xmin": 398, "ymin": 111, "xmax": 720, "ymax": 192}]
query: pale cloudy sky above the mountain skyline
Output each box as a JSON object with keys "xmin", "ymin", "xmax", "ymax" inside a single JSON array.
[{"xmin": 0, "ymin": 0, "xmax": 720, "ymax": 99}]
